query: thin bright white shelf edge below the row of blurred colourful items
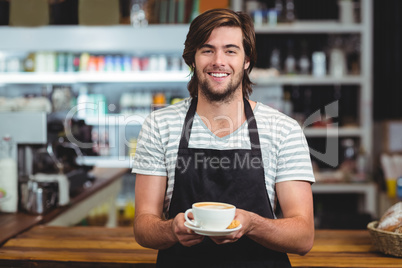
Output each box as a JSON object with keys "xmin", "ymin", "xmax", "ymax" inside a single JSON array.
[{"xmin": 0, "ymin": 71, "xmax": 190, "ymax": 84}]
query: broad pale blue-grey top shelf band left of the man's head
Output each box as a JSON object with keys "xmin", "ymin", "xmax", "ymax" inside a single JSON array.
[{"xmin": 0, "ymin": 24, "xmax": 189, "ymax": 55}]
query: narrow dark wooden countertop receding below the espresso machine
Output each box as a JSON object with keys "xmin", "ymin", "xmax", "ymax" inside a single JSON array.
[{"xmin": 0, "ymin": 167, "xmax": 129, "ymax": 245}]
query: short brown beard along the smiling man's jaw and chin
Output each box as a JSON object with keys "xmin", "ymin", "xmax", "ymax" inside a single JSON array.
[{"xmin": 197, "ymin": 66, "xmax": 244, "ymax": 102}]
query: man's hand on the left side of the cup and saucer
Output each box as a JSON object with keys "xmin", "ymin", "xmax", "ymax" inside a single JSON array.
[{"xmin": 172, "ymin": 213, "xmax": 204, "ymax": 247}]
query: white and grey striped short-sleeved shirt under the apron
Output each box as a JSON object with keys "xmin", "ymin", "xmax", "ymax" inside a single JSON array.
[{"xmin": 132, "ymin": 98, "xmax": 315, "ymax": 217}]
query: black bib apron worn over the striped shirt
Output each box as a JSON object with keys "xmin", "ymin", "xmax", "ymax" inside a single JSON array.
[{"xmin": 157, "ymin": 98, "xmax": 291, "ymax": 268}]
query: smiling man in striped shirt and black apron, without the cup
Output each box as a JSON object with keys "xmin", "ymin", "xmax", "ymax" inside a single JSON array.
[{"xmin": 133, "ymin": 9, "xmax": 314, "ymax": 267}]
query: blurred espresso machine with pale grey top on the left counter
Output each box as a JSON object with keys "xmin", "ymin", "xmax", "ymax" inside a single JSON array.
[{"xmin": 0, "ymin": 112, "xmax": 95, "ymax": 214}]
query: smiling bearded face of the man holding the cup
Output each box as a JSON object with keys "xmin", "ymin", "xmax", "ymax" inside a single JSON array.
[{"xmin": 195, "ymin": 27, "xmax": 250, "ymax": 101}]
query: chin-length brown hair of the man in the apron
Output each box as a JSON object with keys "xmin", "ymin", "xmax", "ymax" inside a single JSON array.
[{"xmin": 183, "ymin": 9, "xmax": 257, "ymax": 98}]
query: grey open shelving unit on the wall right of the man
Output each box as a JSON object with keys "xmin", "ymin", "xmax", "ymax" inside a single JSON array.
[{"xmin": 242, "ymin": 0, "xmax": 378, "ymax": 218}]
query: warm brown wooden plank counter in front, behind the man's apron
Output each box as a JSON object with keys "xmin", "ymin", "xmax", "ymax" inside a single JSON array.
[{"xmin": 0, "ymin": 225, "xmax": 402, "ymax": 268}]
